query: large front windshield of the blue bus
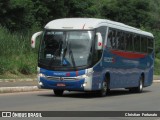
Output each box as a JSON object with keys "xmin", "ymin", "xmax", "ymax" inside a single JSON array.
[{"xmin": 39, "ymin": 30, "xmax": 93, "ymax": 70}]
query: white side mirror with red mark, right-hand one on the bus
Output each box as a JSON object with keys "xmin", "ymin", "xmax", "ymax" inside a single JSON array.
[{"xmin": 96, "ymin": 32, "xmax": 103, "ymax": 50}]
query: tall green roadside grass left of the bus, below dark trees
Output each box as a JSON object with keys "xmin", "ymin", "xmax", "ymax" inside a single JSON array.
[{"xmin": 0, "ymin": 27, "xmax": 37, "ymax": 78}]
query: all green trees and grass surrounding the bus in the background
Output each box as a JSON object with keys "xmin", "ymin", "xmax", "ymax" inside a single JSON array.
[{"xmin": 0, "ymin": 0, "xmax": 160, "ymax": 78}]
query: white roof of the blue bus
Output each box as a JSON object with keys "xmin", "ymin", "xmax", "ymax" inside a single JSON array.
[{"xmin": 45, "ymin": 18, "xmax": 153, "ymax": 37}]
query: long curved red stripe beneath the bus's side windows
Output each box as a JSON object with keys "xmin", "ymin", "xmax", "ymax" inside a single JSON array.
[{"xmin": 111, "ymin": 50, "xmax": 146, "ymax": 59}]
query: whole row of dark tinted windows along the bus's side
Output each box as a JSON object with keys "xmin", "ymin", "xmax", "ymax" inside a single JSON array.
[{"xmin": 107, "ymin": 29, "xmax": 153, "ymax": 53}]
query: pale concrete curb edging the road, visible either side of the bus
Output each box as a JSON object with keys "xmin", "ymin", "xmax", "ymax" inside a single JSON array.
[{"xmin": 0, "ymin": 80, "xmax": 160, "ymax": 93}]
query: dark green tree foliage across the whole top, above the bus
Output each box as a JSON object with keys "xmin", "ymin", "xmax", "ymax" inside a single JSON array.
[{"xmin": 0, "ymin": 0, "xmax": 160, "ymax": 31}]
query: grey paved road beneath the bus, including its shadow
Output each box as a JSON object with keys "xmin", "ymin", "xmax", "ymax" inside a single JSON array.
[{"xmin": 0, "ymin": 83, "xmax": 160, "ymax": 111}]
